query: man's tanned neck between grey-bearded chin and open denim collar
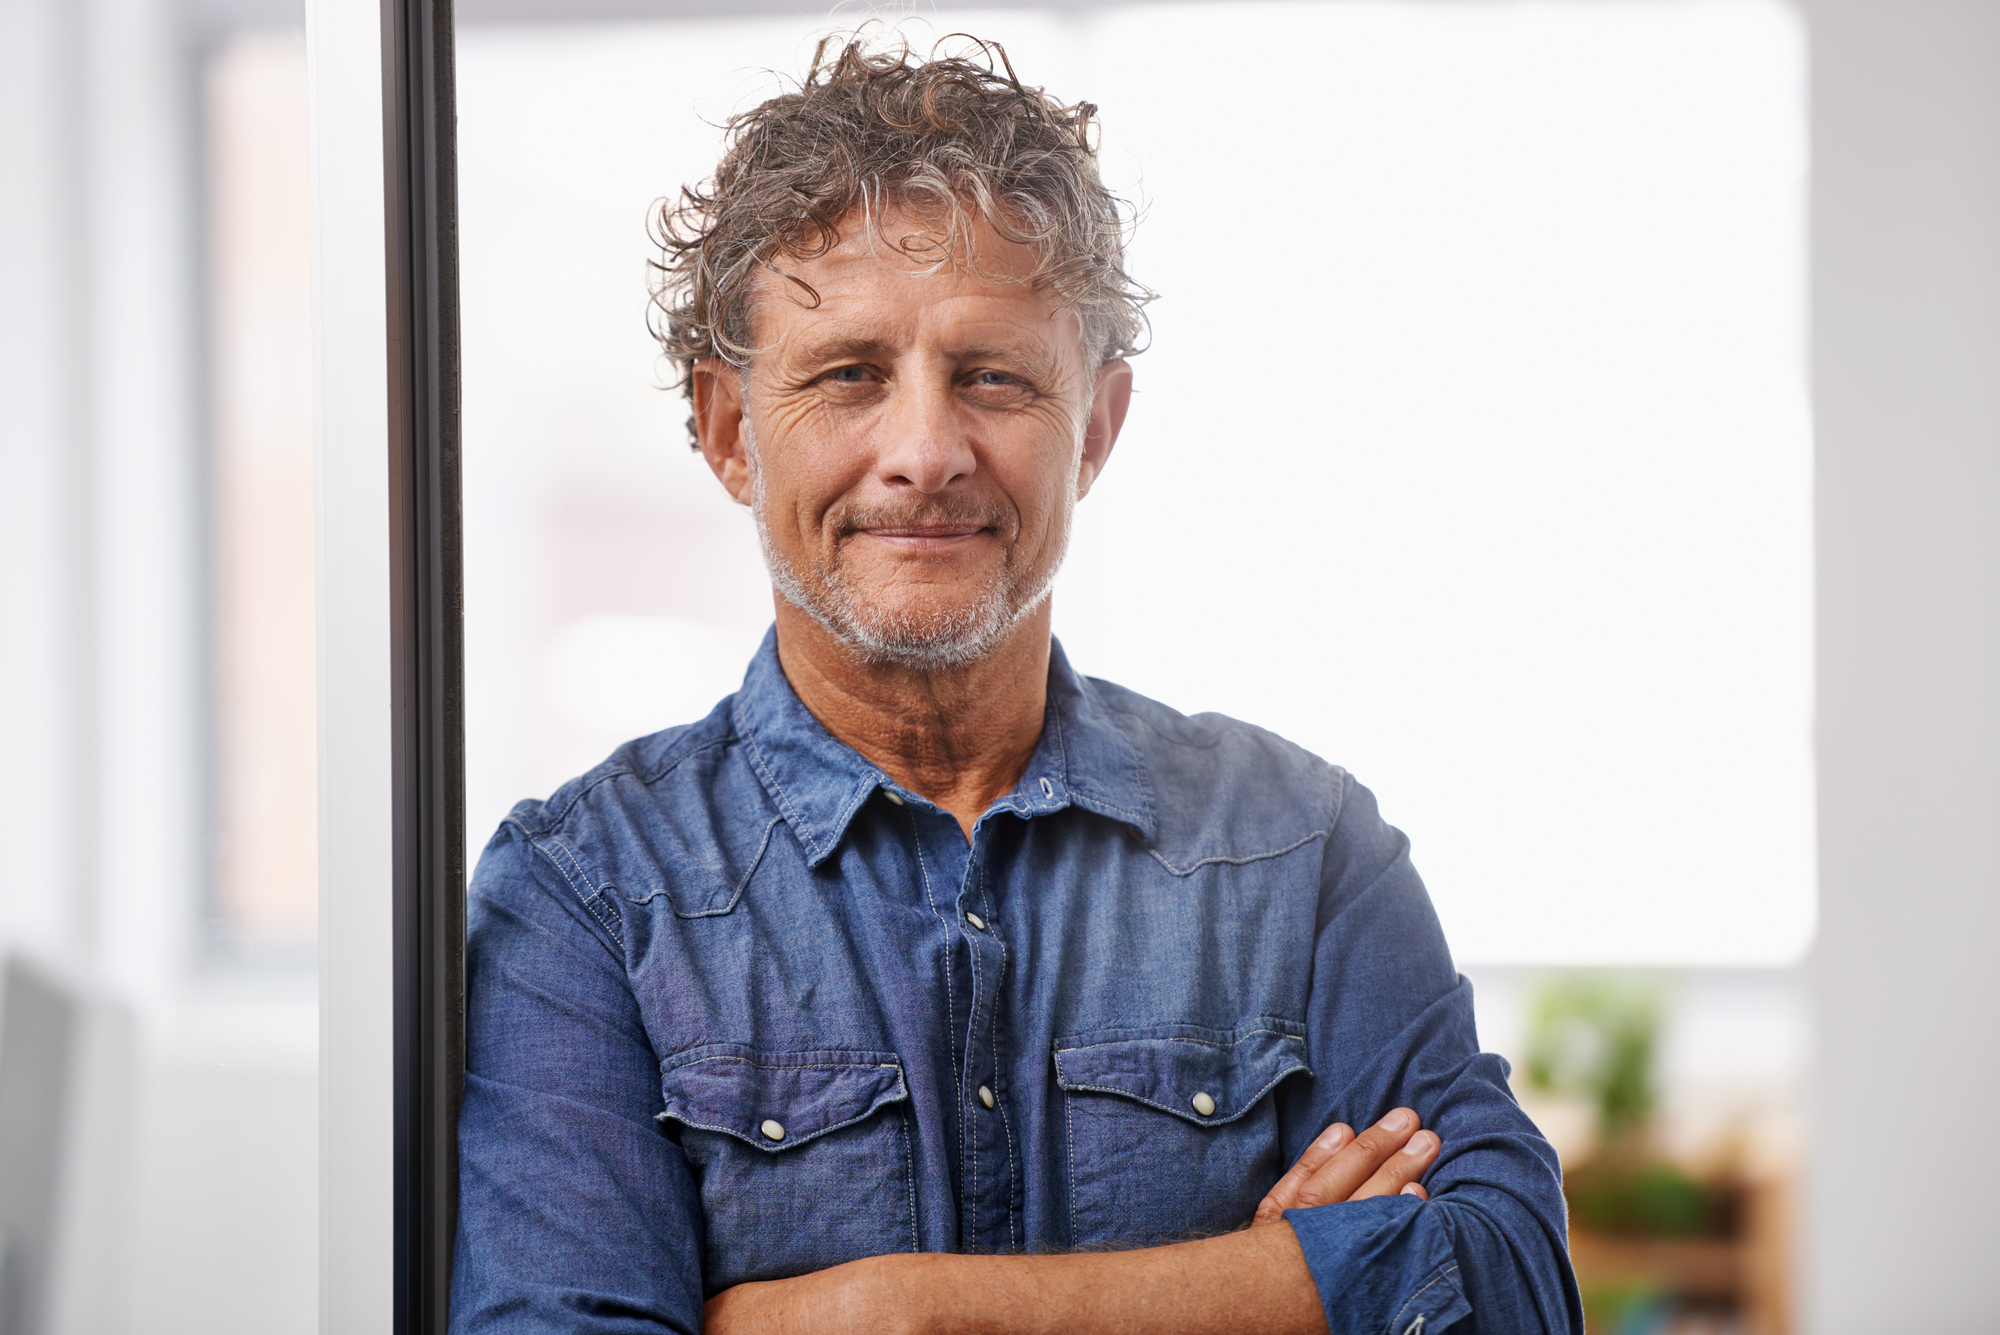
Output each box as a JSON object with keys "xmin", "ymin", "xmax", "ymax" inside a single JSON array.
[{"xmin": 778, "ymin": 598, "xmax": 1050, "ymax": 839}]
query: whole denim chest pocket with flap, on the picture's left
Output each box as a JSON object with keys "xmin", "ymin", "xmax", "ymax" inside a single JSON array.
[{"xmin": 660, "ymin": 1043, "xmax": 916, "ymax": 1293}]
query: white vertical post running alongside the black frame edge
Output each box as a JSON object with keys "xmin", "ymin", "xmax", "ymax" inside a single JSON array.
[{"xmin": 306, "ymin": 0, "xmax": 394, "ymax": 1335}]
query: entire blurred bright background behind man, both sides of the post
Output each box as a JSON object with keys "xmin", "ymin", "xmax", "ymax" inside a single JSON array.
[{"xmin": 0, "ymin": 0, "xmax": 2000, "ymax": 1335}]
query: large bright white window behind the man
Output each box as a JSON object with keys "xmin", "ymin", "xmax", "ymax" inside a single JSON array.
[{"xmin": 460, "ymin": 0, "xmax": 1814, "ymax": 963}]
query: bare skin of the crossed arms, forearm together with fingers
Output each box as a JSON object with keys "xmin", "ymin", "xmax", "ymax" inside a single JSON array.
[{"xmin": 702, "ymin": 1107, "xmax": 1440, "ymax": 1335}]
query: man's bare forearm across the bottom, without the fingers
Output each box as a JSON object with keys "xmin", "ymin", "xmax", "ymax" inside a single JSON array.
[{"xmin": 706, "ymin": 1223, "xmax": 1326, "ymax": 1335}]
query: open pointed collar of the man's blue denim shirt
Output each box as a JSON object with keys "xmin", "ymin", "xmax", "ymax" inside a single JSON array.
[{"xmin": 732, "ymin": 628, "xmax": 1154, "ymax": 867}]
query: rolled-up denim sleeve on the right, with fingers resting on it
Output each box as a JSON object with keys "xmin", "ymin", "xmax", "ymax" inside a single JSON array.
[{"xmin": 1282, "ymin": 775, "xmax": 1584, "ymax": 1335}]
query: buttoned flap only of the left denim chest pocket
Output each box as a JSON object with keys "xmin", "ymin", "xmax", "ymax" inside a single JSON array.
[{"xmin": 660, "ymin": 1043, "xmax": 910, "ymax": 1153}]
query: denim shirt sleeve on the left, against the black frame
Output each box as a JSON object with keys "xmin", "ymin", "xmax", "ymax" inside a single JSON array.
[{"xmin": 450, "ymin": 821, "xmax": 702, "ymax": 1335}]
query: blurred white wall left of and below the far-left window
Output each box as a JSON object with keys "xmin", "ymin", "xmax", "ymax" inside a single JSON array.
[{"xmin": 0, "ymin": 0, "xmax": 320, "ymax": 1335}]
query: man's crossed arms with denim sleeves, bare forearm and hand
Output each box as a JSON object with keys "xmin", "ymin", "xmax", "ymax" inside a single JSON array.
[{"xmin": 452, "ymin": 789, "xmax": 1582, "ymax": 1335}]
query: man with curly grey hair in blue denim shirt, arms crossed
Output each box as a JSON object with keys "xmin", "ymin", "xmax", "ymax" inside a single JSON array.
[{"xmin": 454, "ymin": 33, "xmax": 1582, "ymax": 1335}]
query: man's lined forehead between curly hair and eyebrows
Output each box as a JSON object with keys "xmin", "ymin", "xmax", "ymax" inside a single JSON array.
[{"xmin": 752, "ymin": 210, "xmax": 1082, "ymax": 352}]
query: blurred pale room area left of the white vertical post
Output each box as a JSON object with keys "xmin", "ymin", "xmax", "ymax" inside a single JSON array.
[{"xmin": 0, "ymin": 0, "xmax": 318, "ymax": 1335}]
